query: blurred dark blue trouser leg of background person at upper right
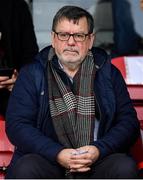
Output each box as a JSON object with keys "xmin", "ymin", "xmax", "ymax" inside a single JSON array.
[{"xmin": 111, "ymin": 0, "xmax": 139, "ymax": 58}]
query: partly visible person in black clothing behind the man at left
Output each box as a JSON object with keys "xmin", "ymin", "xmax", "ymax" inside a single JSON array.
[{"xmin": 0, "ymin": 0, "xmax": 38, "ymax": 115}]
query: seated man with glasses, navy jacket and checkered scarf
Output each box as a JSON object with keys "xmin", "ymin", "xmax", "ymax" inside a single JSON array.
[{"xmin": 6, "ymin": 6, "xmax": 140, "ymax": 179}]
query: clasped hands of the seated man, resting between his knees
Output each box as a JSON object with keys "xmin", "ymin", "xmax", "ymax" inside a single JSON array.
[{"xmin": 57, "ymin": 145, "xmax": 99, "ymax": 172}]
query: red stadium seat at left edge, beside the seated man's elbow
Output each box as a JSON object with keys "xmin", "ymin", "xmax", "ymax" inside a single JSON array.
[{"xmin": 0, "ymin": 116, "xmax": 14, "ymax": 179}]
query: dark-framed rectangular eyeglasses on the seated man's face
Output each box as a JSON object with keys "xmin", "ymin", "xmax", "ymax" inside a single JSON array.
[{"xmin": 54, "ymin": 31, "xmax": 89, "ymax": 42}]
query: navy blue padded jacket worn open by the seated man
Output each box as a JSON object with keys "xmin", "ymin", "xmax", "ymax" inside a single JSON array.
[{"xmin": 6, "ymin": 47, "xmax": 139, "ymax": 169}]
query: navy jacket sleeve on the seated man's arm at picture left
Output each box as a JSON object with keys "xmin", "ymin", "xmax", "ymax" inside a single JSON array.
[{"xmin": 6, "ymin": 65, "xmax": 63, "ymax": 162}]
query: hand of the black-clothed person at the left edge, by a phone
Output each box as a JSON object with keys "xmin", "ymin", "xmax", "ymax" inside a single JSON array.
[{"xmin": 0, "ymin": 69, "xmax": 18, "ymax": 91}]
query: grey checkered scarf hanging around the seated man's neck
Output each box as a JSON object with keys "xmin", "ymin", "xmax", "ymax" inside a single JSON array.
[{"xmin": 47, "ymin": 48, "xmax": 95, "ymax": 148}]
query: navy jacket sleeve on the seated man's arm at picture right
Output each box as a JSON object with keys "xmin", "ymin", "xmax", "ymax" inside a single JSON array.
[{"xmin": 94, "ymin": 66, "xmax": 140, "ymax": 159}]
